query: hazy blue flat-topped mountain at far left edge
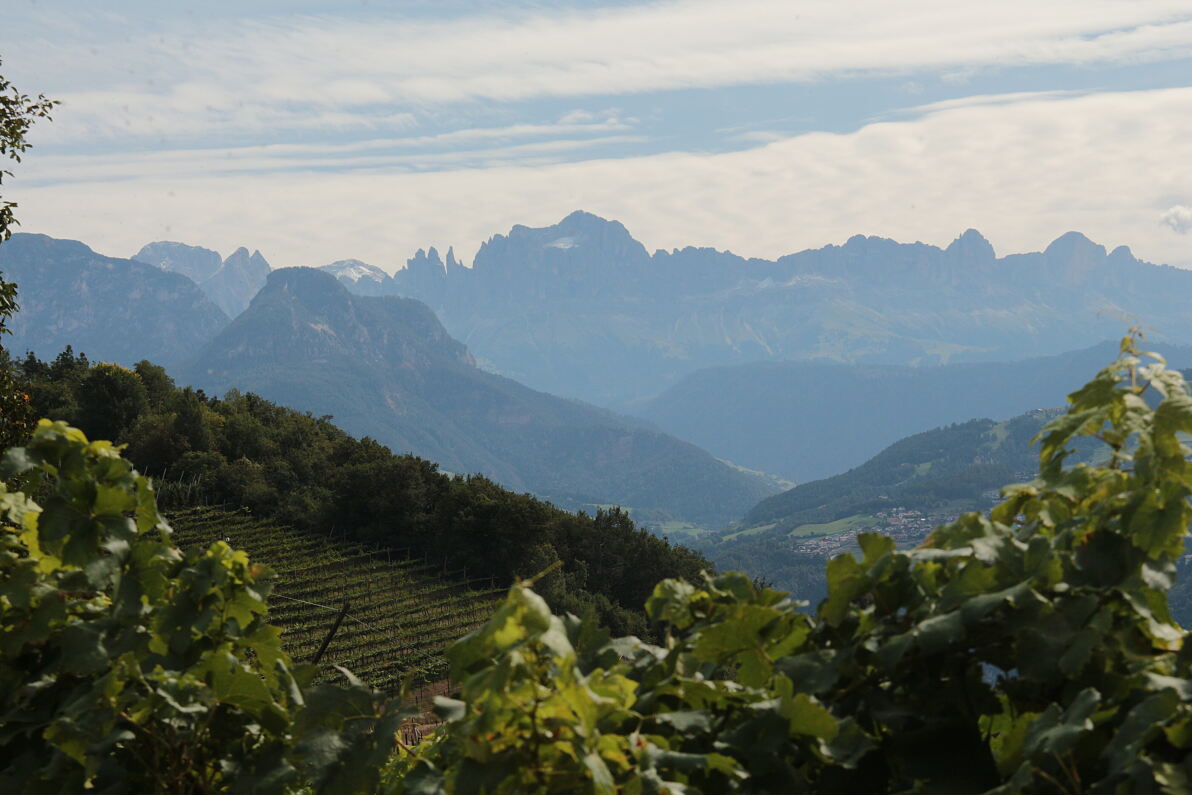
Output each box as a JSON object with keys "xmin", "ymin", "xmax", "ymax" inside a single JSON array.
[{"xmin": 0, "ymin": 235, "xmax": 228, "ymax": 366}]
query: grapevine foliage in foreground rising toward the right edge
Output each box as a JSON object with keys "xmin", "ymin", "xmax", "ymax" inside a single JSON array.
[{"xmin": 387, "ymin": 336, "xmax": 1192, "ymax": 794}]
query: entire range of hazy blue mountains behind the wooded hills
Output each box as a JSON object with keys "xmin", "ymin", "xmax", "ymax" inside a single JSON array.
[{"xmin": 0, "ymin": 212, "xmax": 1192, "ymax": 527}]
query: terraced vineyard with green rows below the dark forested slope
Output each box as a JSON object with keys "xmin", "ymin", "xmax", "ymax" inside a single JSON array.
[{"xmin": 169, "ymin": 508, "xmax": 503, "ymax": 691}]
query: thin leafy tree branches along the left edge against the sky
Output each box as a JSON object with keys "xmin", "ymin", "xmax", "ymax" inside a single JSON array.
[{"xmin": 0, "ymin": 61, "xmax": 57, "ymax": 449}]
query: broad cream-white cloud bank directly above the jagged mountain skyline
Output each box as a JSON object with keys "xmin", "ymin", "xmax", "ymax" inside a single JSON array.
[{"xmin": 12, "ymin": 88, "xmax": 1192, "ymax": 269}]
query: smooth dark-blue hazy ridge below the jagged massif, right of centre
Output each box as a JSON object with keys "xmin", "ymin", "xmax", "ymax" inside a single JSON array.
[{"xmin": 638, "ymin": 342, "xmax": 1192, "ymax": 482}]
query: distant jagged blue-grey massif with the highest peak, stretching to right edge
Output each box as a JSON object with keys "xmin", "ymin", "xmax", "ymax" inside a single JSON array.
[{"xmin": 355, "ymin": 212, "xmax": 1192, "ymax": 410}]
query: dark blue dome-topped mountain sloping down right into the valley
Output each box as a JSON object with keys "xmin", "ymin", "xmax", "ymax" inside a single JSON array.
[{"xmin": 185, "ymin": 268, "xmax": 776, "ymax": 526}]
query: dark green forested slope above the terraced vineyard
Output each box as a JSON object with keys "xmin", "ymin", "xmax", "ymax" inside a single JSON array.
[{"xmin": 17, "ymin": 350, "xmax": 708, "ymax": 632}]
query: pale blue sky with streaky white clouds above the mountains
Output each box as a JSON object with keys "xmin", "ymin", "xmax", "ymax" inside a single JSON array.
[{"xmin": 0, "ymin": 0, "xmax": 1192, "ymax": 272}]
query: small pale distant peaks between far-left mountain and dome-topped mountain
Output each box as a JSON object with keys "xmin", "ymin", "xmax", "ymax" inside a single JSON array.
[{"xmin": 132, "ymin": 241, "xmax": 272, "ymax": 317}]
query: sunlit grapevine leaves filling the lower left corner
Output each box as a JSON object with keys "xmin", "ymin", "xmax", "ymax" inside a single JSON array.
[{"xmin": 0, "ymin": 421, "xmax": 405, "ymax": 793}]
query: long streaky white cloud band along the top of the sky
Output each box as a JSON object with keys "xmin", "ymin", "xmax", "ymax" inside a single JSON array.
[{"xmin": 5, "ymin": 0, "xmax": 1192, "ymax": 141}]
